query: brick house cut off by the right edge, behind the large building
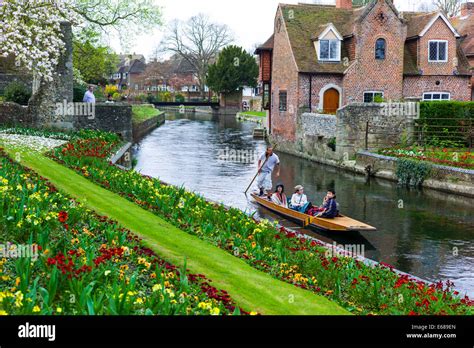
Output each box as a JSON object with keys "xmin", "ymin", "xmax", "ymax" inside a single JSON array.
[{"xmin": 452, "ymin": 2, "xmax": 474, "ymax": 100}]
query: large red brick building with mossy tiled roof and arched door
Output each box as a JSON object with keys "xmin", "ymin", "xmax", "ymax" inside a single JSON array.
[{"xmin": 256, "ymin": 0, "xmax": 471, "ymax": 141}]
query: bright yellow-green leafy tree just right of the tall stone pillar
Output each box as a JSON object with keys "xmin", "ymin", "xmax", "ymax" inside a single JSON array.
[{"xmin": 73, "ymin": 31, "xmax": 119, "ymax": 84}]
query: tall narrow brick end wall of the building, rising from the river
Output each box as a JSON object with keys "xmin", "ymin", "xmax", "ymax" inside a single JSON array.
[{"xmin": 271, "ymin": 8, "xmax": 298, "ymax": 141}]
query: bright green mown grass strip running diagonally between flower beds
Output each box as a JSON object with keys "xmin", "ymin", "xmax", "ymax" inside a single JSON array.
[{"xmin": 0, "ymin": 147, "xmax": 350, "ymax": 315}]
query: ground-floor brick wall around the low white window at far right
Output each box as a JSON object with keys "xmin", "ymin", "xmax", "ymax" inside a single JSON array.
[{"xmin": 403, "ymin": 76, "xmax": 471, "ymax": 101}]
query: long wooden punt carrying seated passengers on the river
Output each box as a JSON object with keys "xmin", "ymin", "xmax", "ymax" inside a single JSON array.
[{"xmin": 251, "ymin": 193, "xmax": 377, "ymax": 232}]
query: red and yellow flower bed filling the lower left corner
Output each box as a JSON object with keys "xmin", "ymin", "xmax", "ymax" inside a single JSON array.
[{"xmin": 0, "ymin": 150, "xmax": 247, "ymax": 315}]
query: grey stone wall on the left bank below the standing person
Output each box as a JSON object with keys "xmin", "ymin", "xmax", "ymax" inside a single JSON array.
[{"xmin": 74, "ymin": 104, "xmax": 133, "ymax": 141}]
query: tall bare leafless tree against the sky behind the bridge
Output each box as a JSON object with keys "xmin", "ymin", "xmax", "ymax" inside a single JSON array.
[{"xmin": 162, "ymin": 14, "xmax": 233, "ymax": 97}]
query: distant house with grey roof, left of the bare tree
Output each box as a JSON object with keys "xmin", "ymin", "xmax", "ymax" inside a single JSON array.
[{"xmin": 110, "ymin": 54, "xmax": 146, "ymax": 91}]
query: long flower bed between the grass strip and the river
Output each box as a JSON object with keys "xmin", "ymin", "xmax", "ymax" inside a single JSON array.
[{"xmin": 49, "ymin": 133, "xmax": 474, "ymax": 315}]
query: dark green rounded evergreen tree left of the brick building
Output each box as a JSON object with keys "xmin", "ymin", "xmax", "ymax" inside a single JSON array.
[{"xmin": 207, "ymin": 46, "xmax": 258, "ymax": 93}]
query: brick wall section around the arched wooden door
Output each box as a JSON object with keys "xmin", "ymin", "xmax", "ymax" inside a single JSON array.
[{"xmin": 299, "ymin": 74, "xmax": 342, "ymax": 112}]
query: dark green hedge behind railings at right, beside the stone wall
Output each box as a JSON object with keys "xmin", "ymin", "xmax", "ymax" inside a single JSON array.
[{"xmin": 417, "ymin": 101, "xmax": 474, "ymax": 148}]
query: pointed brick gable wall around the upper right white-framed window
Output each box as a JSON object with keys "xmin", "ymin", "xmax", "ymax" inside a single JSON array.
[{"xmin": 418, "ymin": 18, "xmax": 457, "ymax": 75}]
